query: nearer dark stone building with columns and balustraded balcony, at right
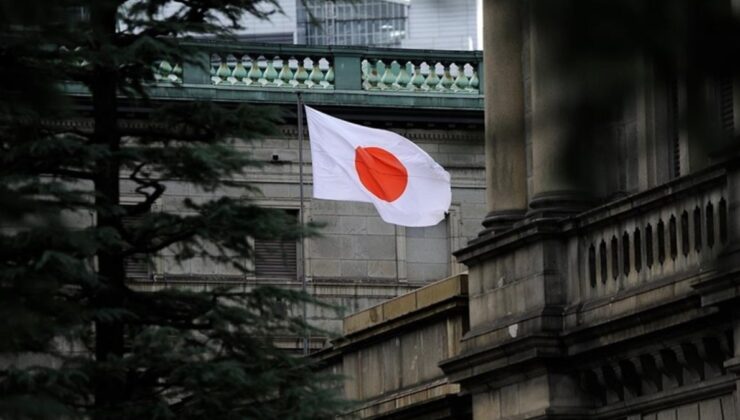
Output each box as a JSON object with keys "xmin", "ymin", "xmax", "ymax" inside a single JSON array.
[{"xmin": 319, "ymin": 0, "xmax": 740, "ymax": 420}]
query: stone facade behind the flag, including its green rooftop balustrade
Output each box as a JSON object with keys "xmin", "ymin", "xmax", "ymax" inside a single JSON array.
[{"xmin": 97, "ymin": 41, "xmax": 487, "ymax": 349}]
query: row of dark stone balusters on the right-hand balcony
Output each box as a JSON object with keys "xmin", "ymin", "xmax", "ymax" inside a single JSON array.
[{"xmin": 576, "ymin": 166, "xmax": 728, "ymax": 299}]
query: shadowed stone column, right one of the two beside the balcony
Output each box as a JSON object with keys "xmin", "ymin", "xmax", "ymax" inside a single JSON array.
[{"xmin": 529, "ymin": 0, "xmax": 589, "ymax": 216}]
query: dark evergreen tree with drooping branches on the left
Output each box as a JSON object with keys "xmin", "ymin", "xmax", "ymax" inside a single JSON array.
[{"xmin": 0, "ymin": 0, "xmax": 341, "ymax": 419}]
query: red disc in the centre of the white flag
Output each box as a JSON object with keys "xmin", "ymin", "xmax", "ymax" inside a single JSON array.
[{"xmin": 355, "ymin": 147, "xmax": 409, "ymax": 203}]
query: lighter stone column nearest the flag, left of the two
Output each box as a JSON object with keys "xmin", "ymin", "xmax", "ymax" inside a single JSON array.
[{"xmin": 483, "ymin": 0, "xmax": 527, "ymax": 232}]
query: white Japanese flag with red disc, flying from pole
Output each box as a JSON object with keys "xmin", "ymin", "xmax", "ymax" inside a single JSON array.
[{"xmin": 306, "ymin": 107, "xmax": 451, "ymax": 226}]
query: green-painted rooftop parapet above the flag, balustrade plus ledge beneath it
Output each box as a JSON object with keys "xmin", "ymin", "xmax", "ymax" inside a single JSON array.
[{"xmin": 64, "ymin": 40, "xmax": 483, "ymax": 111}]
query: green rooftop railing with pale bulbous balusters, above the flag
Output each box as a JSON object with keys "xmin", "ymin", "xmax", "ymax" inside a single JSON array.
[{"xmin": 155, "ymin": 41, "xmax": 482, "ymax": 95}]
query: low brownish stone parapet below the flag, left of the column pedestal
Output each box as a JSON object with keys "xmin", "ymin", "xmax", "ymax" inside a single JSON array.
[{"xmin": 313, "ymin": 274, "xmax": 469, "ymax": 419}]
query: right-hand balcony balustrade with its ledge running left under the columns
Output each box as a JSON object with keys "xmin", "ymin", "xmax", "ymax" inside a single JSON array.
[{"xmin": 455, "ymin": 162, "xmax": 728, "ymax": 306}]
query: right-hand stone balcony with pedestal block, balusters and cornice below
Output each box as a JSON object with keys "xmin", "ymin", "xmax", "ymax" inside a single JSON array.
[{"xmin": 439, "ymin": 159, "xmax": 740, "ymax": 418}]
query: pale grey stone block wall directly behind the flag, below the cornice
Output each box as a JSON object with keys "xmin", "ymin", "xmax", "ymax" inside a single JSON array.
[{"xmin": 122, "ymin": 121, "xmax": 486, "ymax": 332}]
